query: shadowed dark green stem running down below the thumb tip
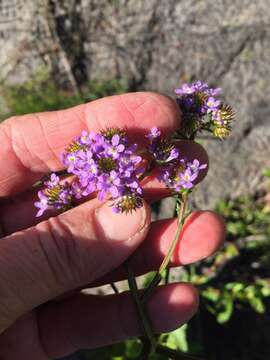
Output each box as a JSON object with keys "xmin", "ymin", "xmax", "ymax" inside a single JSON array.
[{"xmin": 125, "ymin": 260, "xmax": 157, "ymax": 355}]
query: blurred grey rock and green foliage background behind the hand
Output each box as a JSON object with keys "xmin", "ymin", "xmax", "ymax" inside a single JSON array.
[{"xmin": 0, "ymin": 0, "xmax": 270, "ymax": 360}]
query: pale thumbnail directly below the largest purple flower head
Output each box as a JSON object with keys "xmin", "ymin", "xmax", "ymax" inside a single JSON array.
[{"xmin": 95, "ymin": 203, "xmax": 146, "ymax": 242}]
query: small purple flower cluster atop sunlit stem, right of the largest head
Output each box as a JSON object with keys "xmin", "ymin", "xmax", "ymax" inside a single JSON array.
[{"xmin": 147, "ymin": 127, "xmax": 207, "ymax": 192}]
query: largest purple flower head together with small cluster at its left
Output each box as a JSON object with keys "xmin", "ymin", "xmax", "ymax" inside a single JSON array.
[{"xmin": 35, "ymin": 129, "xmax": 143, "ymax": 216}]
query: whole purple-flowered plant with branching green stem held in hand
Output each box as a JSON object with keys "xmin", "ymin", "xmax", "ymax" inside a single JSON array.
[{"xmin": 35, "ymin": 81, "xmax": 234, "ymax": 360}]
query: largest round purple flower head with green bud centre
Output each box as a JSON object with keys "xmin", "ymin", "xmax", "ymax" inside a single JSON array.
[{"xmin": 62, "ymin": 131, "xmax": 142, "ymax": 200}]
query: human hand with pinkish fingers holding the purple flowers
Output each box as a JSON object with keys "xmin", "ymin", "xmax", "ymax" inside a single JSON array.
[{"xmin": 0, "ymin": 93, "xmax": 224, "ymax": 360}]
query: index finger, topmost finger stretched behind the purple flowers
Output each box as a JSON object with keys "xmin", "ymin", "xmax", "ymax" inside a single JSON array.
[{"xmin": 0, "ymin": 92, "xmax": 180, "ymax": 197}]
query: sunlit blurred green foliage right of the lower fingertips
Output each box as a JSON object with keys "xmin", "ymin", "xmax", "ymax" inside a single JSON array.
[{"xmin": 181, "ymin": 190, "xmax": 270, "ymax": 324}]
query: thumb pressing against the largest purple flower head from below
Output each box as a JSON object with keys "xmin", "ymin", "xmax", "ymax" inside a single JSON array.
[{"xmin": 0, "ymin": 199, "xmax": 150, "ymax": 332}]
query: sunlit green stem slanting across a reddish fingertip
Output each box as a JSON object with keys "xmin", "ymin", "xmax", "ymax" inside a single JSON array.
[{"xmin": 141, "ymin": 197, "xmax": 187, "ymax": 304}]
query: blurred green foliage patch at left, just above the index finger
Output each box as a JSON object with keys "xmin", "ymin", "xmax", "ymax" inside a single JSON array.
[{"xmin": 0, "ymin": 69, "xmax": 127, "ymax": 119}]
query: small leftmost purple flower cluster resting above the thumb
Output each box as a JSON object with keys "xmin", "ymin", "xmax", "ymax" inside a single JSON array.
[{"xmin": 34, "ymin": 174, "xmax": 72, "ymax": 217}]
